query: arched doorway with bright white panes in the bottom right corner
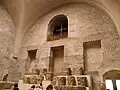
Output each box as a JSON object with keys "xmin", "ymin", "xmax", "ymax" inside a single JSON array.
[{"xmin": 103, "ymin": 70, "xmax": 120, "ymax": 90}]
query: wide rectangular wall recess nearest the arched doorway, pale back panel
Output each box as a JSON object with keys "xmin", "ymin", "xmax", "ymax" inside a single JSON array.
[{"xmin": 83, "ymin": 40, "xmax": 103, "ymax": 71}]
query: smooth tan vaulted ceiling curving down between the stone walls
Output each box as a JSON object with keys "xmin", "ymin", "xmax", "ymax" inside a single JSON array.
[{"xmin": 0, "ymin": 0, "xmax": 120, "ymax": 54}]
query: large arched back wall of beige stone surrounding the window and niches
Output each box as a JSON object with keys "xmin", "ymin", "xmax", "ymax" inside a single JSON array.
[{"xmin": 19, "ymin": 3, "xmax": 120, "ymax": 90}]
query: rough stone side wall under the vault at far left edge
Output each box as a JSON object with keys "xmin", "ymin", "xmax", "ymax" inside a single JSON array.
[{"xmin": 0, "ymin": 5, "xmax": 15, "ymax": 80}]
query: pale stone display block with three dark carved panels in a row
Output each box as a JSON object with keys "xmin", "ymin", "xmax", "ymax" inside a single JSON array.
[{"xmin": 54, "ymin": 75, "xmax": 92, "ymax": 90}]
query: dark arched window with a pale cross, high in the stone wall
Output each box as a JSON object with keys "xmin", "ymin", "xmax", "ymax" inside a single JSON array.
[{"xmin": 47, "ymin": 15, "xmax": 68, "ymax": 41}]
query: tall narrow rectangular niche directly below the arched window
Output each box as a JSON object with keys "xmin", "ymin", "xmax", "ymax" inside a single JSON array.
[{"xmin": 49, "ymin": 46, "xmax": 64, "ymax": 75}]
